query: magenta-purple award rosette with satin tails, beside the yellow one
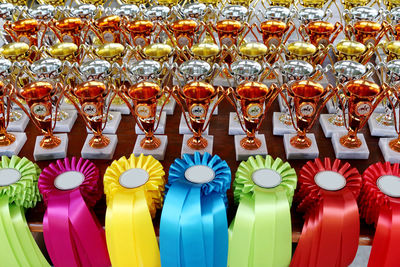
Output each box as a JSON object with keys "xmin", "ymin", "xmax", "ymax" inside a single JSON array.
[{"xmin": 38, "ymin": 157, "xmax": 111, "ymax": 267}]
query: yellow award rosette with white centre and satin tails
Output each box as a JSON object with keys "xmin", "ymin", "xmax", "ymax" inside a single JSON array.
[{"xmin": 104, "ymin": 154, "xmax": 165, "ymax": 267}]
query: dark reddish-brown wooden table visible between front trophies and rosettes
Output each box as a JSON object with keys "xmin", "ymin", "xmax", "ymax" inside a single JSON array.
[{"xmin": 23, "ymin": 93, "xmax": 383, "ymax": 245}]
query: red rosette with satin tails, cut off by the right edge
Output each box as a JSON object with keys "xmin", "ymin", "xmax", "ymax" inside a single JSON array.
[{"xmin": 359, "ymin": 162, "xmax": 400, "ymax": 267}]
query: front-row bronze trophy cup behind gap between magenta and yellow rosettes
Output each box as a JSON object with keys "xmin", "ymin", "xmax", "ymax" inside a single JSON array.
[{"xmin": 64, "ymin": 81, "xmax": 118, "ymax": 159}]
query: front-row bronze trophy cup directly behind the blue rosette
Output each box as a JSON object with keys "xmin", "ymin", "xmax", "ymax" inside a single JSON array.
[{"xmin": 172, "ymin": 81, "xmax": 225, "ymax": 155}]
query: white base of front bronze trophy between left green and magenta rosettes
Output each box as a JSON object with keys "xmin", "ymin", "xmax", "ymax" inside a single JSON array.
[{"xmin": 33, "ymin": 134, "xmax": 68, "ymax": 161}]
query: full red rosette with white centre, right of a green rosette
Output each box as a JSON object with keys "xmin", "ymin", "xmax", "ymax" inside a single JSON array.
[{"xmin": 290, "ymin": 158, "xmax": 361, "ymax": 267}]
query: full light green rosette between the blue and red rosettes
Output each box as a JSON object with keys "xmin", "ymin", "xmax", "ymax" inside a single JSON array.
[{"xmin": 228, "ymin": 156, "xmax": 297, "ymax": 267}]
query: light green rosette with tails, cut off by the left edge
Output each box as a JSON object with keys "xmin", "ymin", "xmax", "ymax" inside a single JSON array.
[{"xmin": 0, "ymin": 156, "xmax": 50, "ymax": 267}]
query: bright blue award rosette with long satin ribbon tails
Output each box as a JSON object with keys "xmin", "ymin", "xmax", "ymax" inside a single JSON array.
[{"xmin": 160, "ymin": 152, "xmax": 231, "ymax": 267}]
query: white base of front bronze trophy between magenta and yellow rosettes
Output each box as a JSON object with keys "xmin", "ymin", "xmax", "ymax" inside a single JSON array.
[{"xmin": 81, "ymin": 134, "xmax": 118, "ymax": 159}]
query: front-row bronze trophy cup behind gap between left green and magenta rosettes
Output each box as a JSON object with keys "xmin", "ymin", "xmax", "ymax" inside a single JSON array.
[{"xmin": 11, "ymin": 80, "xmax": 68, "ymax": 160}]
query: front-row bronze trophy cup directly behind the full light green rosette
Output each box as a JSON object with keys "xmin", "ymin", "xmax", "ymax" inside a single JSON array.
[{"xmin": 228, "ymin": 81, "xmax": 281, "ymax": 161}]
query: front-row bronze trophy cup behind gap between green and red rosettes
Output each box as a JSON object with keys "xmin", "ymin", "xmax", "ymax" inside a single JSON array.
[{"xmin": 281, "ymin": 80, "xmax": 336, "ymax": 159}]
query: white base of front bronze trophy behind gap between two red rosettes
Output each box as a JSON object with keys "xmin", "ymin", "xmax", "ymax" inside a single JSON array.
[{"xmin": 332, "ymin": 132, "xmax": 369, "ymax": 159}]
